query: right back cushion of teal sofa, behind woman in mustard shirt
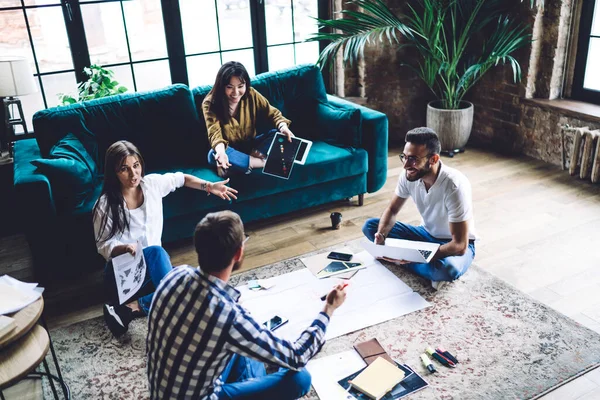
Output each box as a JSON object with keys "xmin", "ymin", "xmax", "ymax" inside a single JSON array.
[{"xmin": 192, "ymin": 64, "xmax": 327, "ymax": 139}]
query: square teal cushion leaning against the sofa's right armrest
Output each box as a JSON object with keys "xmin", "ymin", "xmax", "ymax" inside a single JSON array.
[{"xmin": 316, "ymin": 103, "xmax": 362, "ymax": 147}]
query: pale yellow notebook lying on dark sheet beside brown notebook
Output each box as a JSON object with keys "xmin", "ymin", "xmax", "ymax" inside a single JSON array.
[{"xmin": 350, "ymin": 357, "xmax": 404, "ymax": 400}]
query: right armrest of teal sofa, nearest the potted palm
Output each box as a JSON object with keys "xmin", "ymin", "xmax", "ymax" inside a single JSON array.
[{"xmin": 327, "ymin": 94, "xmax": 388, "ymax": 193}]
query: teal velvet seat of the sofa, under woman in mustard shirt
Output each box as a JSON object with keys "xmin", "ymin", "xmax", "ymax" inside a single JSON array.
[{"xmin": 152, "ymin": 142, "xmax": 368, "ymax": 219}]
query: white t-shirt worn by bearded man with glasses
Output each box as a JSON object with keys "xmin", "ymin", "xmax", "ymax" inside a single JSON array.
[{"xmin": 396, "ymin": 161, "xmax": 477, "ymax": 239}]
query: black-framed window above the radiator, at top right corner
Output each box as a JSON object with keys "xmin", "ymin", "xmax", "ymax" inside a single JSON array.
[{"xmin": 571, "ymin": 0, "xmax": 600, "ymax": 104}]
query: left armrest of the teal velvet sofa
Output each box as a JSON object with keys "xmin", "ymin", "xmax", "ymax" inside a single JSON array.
[{"xmin": 13, "ymin": 139, "xmax": 56, "ymax": 225}]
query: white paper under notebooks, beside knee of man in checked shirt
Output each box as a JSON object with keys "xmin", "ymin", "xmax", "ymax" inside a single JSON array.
[{"xmin": 306, "ymin": 350, "xmax": 367, "ymax": 400}]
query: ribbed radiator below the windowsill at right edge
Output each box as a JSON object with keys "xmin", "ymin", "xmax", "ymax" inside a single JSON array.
[{"xmin": 562, "ymin": 125, "xmax": 600, "ymax": 183}]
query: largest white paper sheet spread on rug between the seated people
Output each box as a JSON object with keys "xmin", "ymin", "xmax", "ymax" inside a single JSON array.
[{"xmin": 238, "ymin": 251, "xmax": 430, "ymax": 340}]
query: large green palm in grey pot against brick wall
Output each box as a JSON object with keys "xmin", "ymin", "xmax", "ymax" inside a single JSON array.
[{"xmin": 310, "ymin": 0, "xmax": 533, "ymax": 155}]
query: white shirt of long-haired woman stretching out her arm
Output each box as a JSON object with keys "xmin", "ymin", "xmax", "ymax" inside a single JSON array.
[{"xmin": 94, "ymin": 172, "xmax": 185, "ymax": 261}]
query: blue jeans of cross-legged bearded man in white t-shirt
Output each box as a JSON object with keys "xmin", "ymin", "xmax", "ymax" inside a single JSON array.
[{"xmin": 363, "ymin": 218, "xmax": 475, "ymax": 281}]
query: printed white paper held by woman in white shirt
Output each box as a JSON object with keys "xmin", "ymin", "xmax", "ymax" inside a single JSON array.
[{"xmin": 112, "ymin": 240, "xmax": 146, "ymax": 304}]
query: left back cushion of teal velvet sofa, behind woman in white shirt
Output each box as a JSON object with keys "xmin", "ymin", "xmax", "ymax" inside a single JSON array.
[{"xmin": 33, "ymin": 84, "xmax": 208, "ymax": 173}]
